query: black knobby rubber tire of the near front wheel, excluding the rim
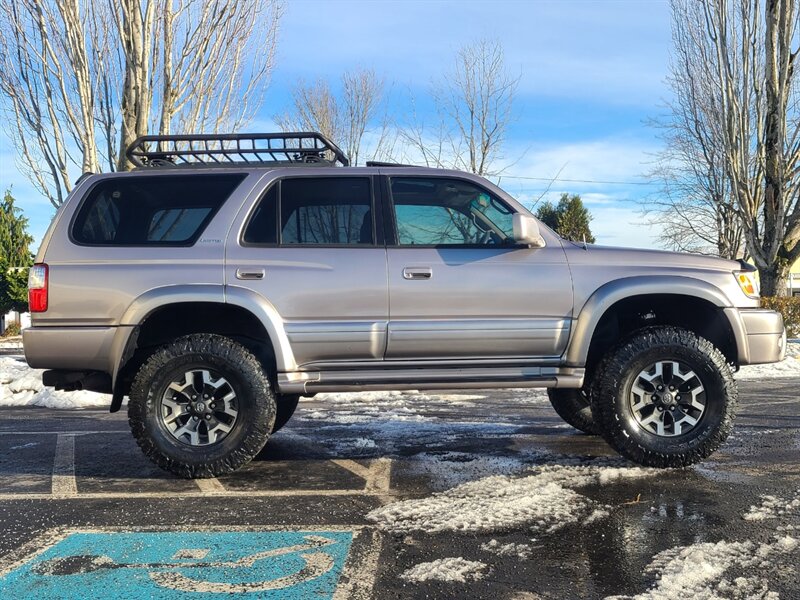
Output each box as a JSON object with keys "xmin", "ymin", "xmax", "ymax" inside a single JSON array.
[{"xmin": 591, "ymin": 326, "xmax": 738, "ymax": 467}]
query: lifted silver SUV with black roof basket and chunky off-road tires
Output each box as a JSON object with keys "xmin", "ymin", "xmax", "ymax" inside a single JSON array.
[{"xmin": 24, "ymin": 133, "xmax": 785, "ymax": 477}]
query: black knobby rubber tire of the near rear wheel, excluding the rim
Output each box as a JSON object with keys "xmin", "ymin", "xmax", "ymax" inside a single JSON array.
[{"xmin": 128, "ymin": 334, "xmax": 276, "ymax": 479}]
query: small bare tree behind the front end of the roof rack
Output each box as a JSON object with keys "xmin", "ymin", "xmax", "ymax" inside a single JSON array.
[{"xmin": 275, "ymin": 69, "xmax": 389, "ymax": 165}]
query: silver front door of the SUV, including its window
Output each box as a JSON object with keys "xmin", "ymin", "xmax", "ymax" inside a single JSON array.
[{"xmin": 386, "ymin": 176, "xmax": 572, "ymax": 359}]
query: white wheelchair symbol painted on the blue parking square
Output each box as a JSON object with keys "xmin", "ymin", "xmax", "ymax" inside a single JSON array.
[{"xmin": 33, "ymin": 535, "xmax": 336, "ymax": 594}]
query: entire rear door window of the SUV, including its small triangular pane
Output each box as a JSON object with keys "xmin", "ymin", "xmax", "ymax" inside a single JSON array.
[{"xmin": 243, "ymin": 177, "xmax": 375, "ymax": 246}]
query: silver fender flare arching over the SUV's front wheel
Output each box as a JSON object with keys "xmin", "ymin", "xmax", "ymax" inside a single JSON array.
[{"xmin": 565, "ymin": 275, "xmax": 741, "ymax": 366}]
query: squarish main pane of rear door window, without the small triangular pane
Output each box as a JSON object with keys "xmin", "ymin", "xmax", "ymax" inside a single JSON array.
[{"xmin": 280, "ymin": 177, "xmax": 374, "ymax": 244}]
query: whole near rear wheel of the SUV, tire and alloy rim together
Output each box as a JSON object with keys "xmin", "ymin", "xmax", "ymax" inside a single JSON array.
[{"xmin": 128, "ymin": 334, "xmax": 275, "ymax": 478}]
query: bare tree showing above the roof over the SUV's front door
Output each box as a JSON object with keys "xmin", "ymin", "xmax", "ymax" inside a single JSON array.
[{"xmin": 401, "ymin": 40, "xmax": 519, "ymax": 175}]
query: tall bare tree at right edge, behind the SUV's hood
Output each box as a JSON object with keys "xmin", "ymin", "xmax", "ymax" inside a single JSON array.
[{"xmin": 672, "ymin": 0, "xmax": 800, "ymax": 295}]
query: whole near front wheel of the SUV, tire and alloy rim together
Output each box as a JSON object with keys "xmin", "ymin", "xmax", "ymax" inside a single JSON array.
[{"xmin": 592, "ymin": 327, "xmax": 738, "ymax": 467}]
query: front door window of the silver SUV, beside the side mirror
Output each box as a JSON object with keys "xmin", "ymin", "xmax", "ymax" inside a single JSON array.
[{"xmin": 392, "ymin": 177, "xmax": 514, "ymax": 246}]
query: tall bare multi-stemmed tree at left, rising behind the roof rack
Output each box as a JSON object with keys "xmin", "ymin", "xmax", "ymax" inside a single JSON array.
[{"xmin": 0, "ymin": 0, "xmax": 282, "ymax": 206}]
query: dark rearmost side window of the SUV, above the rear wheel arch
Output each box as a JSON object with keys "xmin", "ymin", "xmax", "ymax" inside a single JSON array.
[{"xmin": 72, "ymin": 173, "xmax": 245, "ymax": 246}]
